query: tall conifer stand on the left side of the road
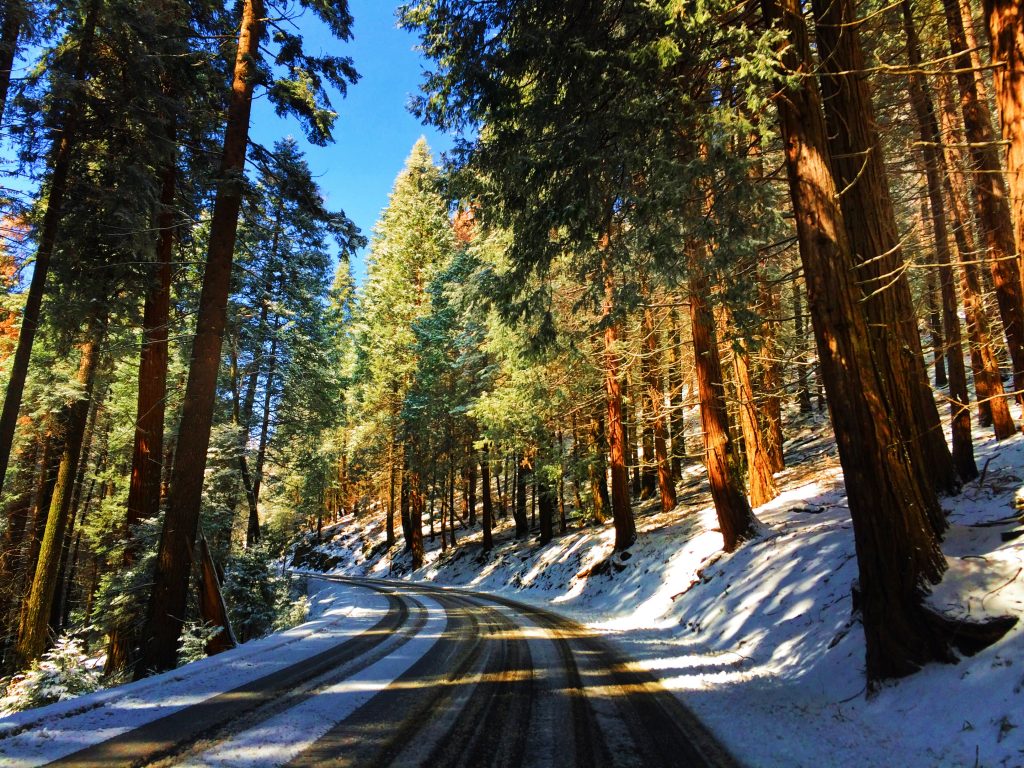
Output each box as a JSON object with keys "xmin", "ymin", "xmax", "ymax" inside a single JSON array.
[{"xmin": 0, "ymin": 0, "xmax": 364, "ymax": 679}]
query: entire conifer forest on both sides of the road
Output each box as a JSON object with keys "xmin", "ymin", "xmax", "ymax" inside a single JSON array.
[{"xmin": 0, "ymin": 0, "xmax": 1024, "ymax": 696}]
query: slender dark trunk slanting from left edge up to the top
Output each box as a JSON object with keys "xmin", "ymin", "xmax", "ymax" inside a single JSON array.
[{"xmin": 0, "ymin": 0, "xmax": 100, "ymax": 501}]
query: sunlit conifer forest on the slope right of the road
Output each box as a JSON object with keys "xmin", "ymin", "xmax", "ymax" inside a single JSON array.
[{"xmin": 346, "ymin": 0, "xmax": 1024, "ymax": 683}]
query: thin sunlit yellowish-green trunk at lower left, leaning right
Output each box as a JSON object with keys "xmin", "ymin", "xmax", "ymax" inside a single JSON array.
[{"xmin": 15, "ymin": 318, "xmax": 106, "ymax": 666}]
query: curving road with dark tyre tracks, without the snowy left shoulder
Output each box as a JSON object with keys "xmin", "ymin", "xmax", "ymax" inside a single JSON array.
[{"xmin": 32, "ymin": 577, "xmax": 736, "ymax": 768}]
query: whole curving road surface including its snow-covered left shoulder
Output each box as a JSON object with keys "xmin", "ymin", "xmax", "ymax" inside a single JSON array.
[{"xmin": 0, "ymin": 578, "xmax": 735, "ymax": 768}]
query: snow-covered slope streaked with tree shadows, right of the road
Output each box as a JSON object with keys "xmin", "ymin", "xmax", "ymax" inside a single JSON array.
[{"xmin": 301, "ymin": 415, "xmax": 1024, "ymax": 766}]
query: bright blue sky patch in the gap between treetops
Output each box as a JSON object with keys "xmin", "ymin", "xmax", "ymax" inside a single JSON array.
[{"xmin": 245, "ymin": 0, "xmax": 452, "ymax": 280}]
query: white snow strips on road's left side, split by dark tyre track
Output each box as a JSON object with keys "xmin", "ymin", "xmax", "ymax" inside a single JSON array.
[{"xmin": 0, "ymin": 580, "xmax": 445, "ymax": 768}]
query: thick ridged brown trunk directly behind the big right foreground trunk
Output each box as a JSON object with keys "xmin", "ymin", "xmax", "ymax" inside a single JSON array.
[{"xmin": 812, "ymin": 0, "xmax": 958, "ymax": 493}]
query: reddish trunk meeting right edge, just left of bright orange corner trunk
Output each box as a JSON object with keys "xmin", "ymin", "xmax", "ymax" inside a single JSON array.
[{"xmin": 942, "ymin": 0, "xmax": 1024, "ymax": 402}]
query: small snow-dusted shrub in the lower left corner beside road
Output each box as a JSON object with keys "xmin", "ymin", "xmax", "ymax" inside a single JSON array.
[{"xmin": 0, "ymin": 635, "xmax": 102, "ymax": 714}]
